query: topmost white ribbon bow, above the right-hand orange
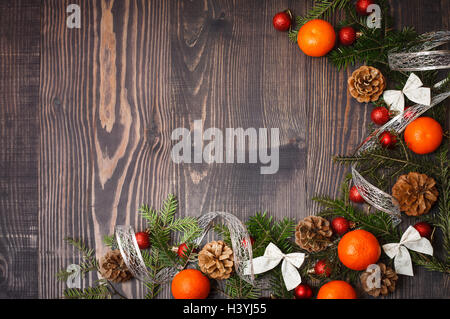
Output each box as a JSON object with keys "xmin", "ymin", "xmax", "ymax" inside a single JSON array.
[{"xmin": 383, "ymin": 73, "xmax": 431, "ymax": 113}]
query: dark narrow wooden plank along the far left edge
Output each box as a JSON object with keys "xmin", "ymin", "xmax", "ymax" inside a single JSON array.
[{"xmin": 0, "ymin": 1, "xmax": 40, "ymax": 298}]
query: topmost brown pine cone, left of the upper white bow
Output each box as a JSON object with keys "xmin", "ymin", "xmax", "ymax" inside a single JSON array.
[{"xmin": 347, "ymin": 65, "xmax": 386, "ymax": 103}]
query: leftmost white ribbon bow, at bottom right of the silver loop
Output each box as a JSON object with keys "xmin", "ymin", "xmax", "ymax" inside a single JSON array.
[{"xmin": 244, "ymin": 243, "xmax": 305, "ymax": 290}]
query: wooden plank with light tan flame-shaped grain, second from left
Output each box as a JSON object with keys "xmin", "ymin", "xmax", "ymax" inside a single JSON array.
[{"xmin": 39, "ymin": 0, "xmax": 175, "ymax": 298}]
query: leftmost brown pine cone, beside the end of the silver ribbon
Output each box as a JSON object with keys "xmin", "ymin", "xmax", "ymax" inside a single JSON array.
[{"xmin": 99, "ymin": 249, "xmax": 133, "ymax": 283}]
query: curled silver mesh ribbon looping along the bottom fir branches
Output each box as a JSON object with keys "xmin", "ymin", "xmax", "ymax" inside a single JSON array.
[{"xmin": 114, "ymin": 212, "xmax": 254, "ymax": 284}]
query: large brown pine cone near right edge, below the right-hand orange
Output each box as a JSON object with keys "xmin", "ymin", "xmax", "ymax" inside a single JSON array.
[{"xmin": 392, "ymin": 172, "xmax": 439, "ymax": 216}]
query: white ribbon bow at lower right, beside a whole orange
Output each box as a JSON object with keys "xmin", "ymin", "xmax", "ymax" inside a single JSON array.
[{"xmin": 383, "ymin": 226, "xmax": 433, "ymax": 276}]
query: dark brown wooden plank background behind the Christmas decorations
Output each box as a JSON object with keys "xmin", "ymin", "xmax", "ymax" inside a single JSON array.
[{"xmin": 0, "ymin": 0, "xmax": 450, "ymax": 298}]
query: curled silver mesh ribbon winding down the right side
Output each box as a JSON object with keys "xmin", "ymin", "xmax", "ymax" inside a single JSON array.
[{"xmin": 352, "ymin": 31, "xmax": 450, "ymax": 225}]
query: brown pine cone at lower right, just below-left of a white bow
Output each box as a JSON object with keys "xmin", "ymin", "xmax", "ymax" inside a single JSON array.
[{"xmin": 360, "ymin": 263, "xmax": 398, "ymax": 297}]
